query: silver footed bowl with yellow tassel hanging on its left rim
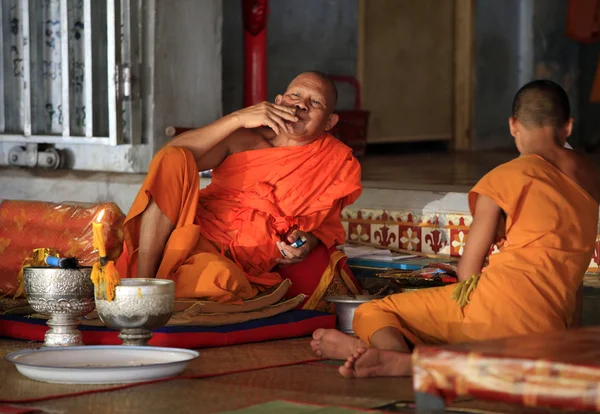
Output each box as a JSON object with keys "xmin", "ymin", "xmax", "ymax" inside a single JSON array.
[{"xmin": 96, "ymin": 279, "xmax": 175, "ymax": 346}]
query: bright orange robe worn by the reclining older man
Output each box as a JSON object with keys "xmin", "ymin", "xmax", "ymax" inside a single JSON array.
[{"xmin": 118, "ymin": 134, "xmax": 362, "ymax": 303}]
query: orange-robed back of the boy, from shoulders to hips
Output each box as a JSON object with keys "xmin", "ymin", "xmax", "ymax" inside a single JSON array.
[{"xmin": 463, "ymin": 150, "xmax": 598, "ymax": 339}]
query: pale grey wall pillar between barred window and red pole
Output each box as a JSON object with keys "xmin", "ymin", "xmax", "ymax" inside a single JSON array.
[{"xmin": 148, "ymin": 0, "xmax": 224, "ymax": 151}]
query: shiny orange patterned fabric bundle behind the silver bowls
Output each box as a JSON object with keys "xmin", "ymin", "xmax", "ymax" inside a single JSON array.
[{"xmin": 0, "ymin": 200, "xmax": 125, "ymax": 293}]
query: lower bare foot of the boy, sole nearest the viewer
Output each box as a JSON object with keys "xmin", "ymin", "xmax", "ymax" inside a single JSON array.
[{"xmin": 339, "ymin": 348, "xmax": 412, "ymax": 378}]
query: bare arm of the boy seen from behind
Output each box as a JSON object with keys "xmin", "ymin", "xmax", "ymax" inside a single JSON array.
[{"xmin": 458, "ymin": 194, "xmax": 502, "ymax": 281}]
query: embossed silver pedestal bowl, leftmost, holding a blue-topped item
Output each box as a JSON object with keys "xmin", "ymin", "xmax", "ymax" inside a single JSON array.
[{"xmin": 23, "ymin": 267, "xmax": 94, "ymax": 346}]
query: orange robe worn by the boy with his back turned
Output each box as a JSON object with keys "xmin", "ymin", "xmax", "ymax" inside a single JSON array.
[{"xmin": 353, "ymin": 155, "xmax": 598, "ymax": 345}]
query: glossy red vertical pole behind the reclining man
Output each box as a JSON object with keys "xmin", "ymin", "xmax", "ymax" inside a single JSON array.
[{"xmin": 242, "ymin": 0, "xmax": 269, "ymax": 107}]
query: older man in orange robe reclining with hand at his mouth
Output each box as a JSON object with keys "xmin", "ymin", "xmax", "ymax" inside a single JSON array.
[{"xmin": 117, "ymin": 72, "xmax": 362, "ymax": 305}]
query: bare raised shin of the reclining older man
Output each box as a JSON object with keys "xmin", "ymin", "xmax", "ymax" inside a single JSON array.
[{"xmin": 137, "ymin": 198, "xmax": 175, "ymax": 278}]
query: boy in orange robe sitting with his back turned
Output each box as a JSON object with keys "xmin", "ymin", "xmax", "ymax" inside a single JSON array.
[{"xmin": 312, "ymin": 80, "xmax": 600, "ymax": 377}]
